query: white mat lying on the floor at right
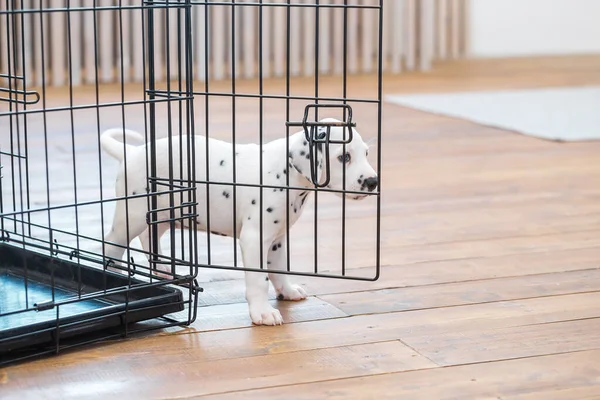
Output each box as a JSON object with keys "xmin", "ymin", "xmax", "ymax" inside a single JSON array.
[{"xmin": 386, "ymin": 86, "xmax": 600, "ymax": 141}]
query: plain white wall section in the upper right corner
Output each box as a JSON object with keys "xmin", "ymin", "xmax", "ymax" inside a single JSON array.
[{"xmin": 467, "ymin": 0, "xmax": 600, "ymax": 57}]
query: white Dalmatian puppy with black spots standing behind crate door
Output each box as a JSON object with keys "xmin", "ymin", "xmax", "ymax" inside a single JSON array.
[{"xmin": 101, "ymin": 119, "xmax": 378, "ymax": 325}]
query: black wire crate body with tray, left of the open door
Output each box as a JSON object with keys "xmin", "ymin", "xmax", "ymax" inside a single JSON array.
[{"xmin": 0, "ymin": 0, "xmax": 200, "ymax": 364}]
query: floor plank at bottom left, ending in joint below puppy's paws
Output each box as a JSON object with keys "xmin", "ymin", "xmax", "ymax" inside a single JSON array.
[{"xmin": 3, "ymin": 338, "xmax": 436, "ymax": 400}]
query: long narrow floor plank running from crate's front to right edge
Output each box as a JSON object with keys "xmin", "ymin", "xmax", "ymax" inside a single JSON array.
[{"xmin": 62, "ymin": 292, "xmax": 600, "ymax": 361}]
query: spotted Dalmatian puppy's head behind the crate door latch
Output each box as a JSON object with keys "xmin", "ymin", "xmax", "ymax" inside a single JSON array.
[{"xmin": 288, "ymin": 118, "xmax": 379, "ymax": 200}]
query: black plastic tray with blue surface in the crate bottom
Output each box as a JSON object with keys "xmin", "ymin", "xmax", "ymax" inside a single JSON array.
[{"xmin": 0, "ymin": 243, "xmax": 184, "ymax": 362}]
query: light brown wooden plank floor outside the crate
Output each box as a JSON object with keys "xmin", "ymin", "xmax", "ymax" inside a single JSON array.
[{"xmin": 0, "ymin": 57, "xmax": 600, "ymax": 400}]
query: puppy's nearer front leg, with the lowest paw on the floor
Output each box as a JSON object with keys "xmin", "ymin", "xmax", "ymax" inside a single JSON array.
[{"xmin": 240, "ymin": 225, "xmax": 283, "ymax": 325}]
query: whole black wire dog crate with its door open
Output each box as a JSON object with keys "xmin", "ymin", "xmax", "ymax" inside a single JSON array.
[{"xmin": 0, "ymin": 0, "xmax": 383, "ymax": 365}]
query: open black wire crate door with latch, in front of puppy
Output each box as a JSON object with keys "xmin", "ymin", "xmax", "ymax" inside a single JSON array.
[{"xmin": 183, "ymin": 0, "xmax": 383, "ymax": 280}]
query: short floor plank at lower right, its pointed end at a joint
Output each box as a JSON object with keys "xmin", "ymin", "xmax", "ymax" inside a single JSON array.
[{"xmin": 402, "ymin": 318, "xmax": 600, "ymax": 366}]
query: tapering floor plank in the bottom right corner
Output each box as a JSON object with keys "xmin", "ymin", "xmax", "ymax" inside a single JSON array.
[{"xmin": 198, "ymin": 350, "xmax": 600, "ymax": 400}]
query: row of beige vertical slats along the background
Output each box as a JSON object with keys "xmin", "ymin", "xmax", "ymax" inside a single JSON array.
[{"xmin": 0, "ymin": 0, "xmax": 467, "ymax": 86}]
